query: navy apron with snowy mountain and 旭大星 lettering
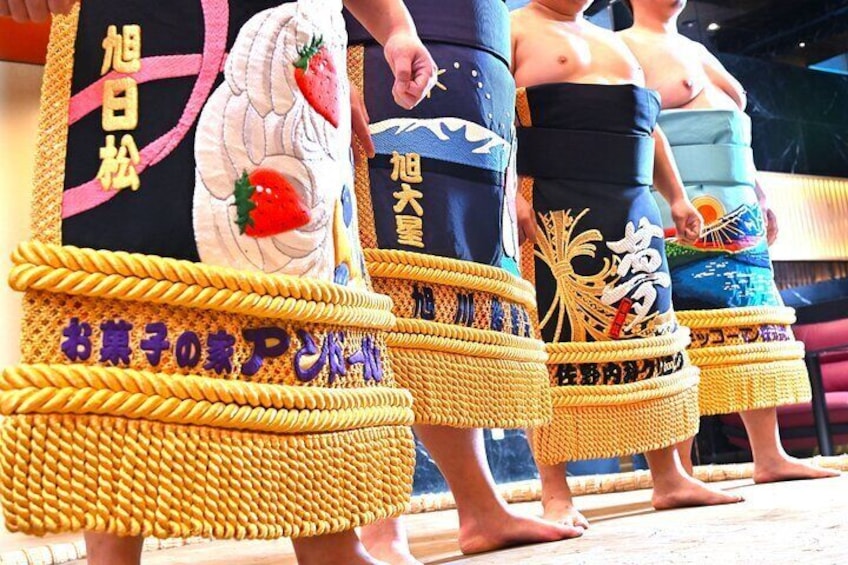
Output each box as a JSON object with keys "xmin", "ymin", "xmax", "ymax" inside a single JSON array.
[{"xmin": 348, "ymin": 0, "xmax": 550, "ymax": 428}]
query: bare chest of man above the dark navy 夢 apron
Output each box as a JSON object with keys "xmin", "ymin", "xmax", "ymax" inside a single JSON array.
[{"xmin": 512, "ymin": 6, "xmax": 644, "ymax": 87}]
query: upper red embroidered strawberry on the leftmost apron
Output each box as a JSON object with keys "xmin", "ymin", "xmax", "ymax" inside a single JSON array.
[{"xmin": 294, "ymin": 36, "xmax": 341, "ymax": 127}]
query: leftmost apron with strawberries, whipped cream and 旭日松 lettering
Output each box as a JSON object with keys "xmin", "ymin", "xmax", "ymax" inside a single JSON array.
[{"xmin": 0, "ymin": 0, "xmax": 414, "ymax": 538}]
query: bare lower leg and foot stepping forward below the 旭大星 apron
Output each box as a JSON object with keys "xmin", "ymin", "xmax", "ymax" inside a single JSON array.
[{"xmin": 415, "ymin": 426, "xmax": 583, "ymax": 553}]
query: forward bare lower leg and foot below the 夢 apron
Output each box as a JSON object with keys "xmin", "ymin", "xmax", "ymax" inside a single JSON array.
[{"xmin": 645, "ymin": 445, "xmax": 742, "ymax": 510}]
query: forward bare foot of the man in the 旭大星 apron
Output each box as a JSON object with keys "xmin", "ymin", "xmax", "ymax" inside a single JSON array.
[{"xmin": 459, "ymin": 509, "xmax": 583, "ymax": 555}]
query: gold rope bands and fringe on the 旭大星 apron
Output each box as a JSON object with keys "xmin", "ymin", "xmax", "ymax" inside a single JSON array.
[{"xmin": 365, "ymin": 249, "xmax": 551, "ymax": 428}]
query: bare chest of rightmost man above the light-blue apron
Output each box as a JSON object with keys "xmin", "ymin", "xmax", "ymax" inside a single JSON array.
[{"xmin": 620, "ymin": 29, "xmax": 737, "ymax": 110}]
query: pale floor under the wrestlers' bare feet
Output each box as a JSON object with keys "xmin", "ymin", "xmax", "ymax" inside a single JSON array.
[{"xmin": 0, "ymin": 475, "xmax": 848, "ymax": 565}]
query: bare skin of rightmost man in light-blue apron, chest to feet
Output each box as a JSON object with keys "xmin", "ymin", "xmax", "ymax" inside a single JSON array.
[{"xmin": 619, "ymin": 0, "xmax": 839, "ymax": 483}]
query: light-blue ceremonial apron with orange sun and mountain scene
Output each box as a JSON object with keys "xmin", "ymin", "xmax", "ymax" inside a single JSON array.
[{"xmin": 658, "ymin": 110, "xmax": 810, "ymax": 415}]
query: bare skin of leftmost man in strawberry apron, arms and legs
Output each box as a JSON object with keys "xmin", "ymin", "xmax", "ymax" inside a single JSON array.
[{"xmin": 8, "ymin": 0, "xmax": 436, "ymax": 565}]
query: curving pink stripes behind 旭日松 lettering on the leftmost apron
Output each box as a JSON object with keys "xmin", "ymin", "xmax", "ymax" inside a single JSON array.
[{"xmin": 62, "ymin": 0, "xmax": 230, "ymax": 219}]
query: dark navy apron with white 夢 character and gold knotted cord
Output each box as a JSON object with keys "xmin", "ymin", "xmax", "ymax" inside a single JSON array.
[{"xmin": 517, "ymin": 83, "xmax": 698, "ymax": 464}]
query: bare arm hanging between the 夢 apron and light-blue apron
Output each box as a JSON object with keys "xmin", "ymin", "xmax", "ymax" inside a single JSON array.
[{"xmin": 653, "ymin": 126, "xmax": 703, "ymax": 242}]
